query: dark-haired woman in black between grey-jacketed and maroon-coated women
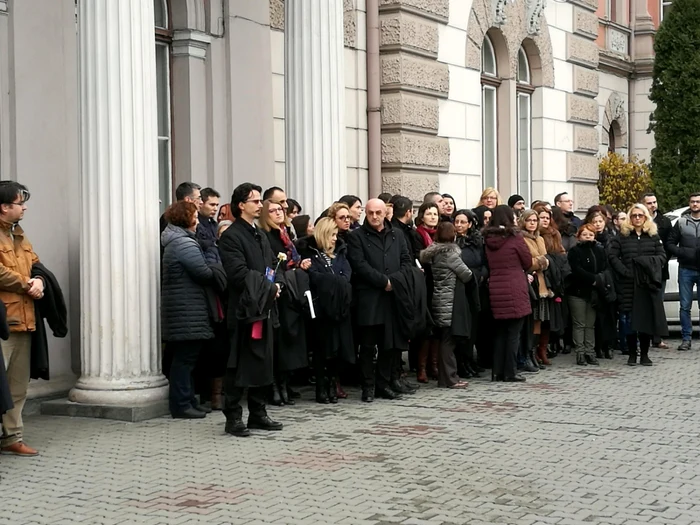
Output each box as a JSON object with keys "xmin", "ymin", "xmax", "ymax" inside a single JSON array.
[{"xmin": 454, "ymin": 210, "xmax": 486, "ymax": 378}]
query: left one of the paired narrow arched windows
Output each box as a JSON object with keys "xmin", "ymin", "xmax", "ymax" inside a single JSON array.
[{"xmin": 481, "ymin": 36, "xmax": 501, "ymax": 188}]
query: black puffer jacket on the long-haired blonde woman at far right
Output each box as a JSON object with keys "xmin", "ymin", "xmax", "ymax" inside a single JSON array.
[{"xmin": 608, "ymin": 231, "xmax": 666, "ymax": 312}]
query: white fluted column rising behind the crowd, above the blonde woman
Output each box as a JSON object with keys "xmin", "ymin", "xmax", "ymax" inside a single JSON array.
[{"xmin": 284, "ymin": 0, "xmax": 347, "ymax": 217}]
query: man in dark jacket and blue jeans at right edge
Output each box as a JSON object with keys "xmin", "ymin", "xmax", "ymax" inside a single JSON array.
[{"xmin": 666, "ymin": 193, "xmax": 700, "ymax": 352}]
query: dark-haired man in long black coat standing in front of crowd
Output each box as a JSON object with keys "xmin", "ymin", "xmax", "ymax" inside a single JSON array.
[{"xmin": 219, "ymin": 182, "xmax": 282, "ymax": 436}]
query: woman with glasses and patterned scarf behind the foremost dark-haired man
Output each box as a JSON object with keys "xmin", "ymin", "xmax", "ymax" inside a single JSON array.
[{"xmin": 259, "ymin": 200, "xmax": 311, "ymax": 406}]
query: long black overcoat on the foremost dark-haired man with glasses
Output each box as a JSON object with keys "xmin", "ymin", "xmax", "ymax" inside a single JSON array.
[{"xmin": 219, "ymin": 219, "xmax": 284, "ymax": 387}]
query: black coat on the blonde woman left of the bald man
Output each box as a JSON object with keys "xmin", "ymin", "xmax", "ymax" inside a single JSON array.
[{"xmin": 297, "ymin": 237, "xmax": 355, "ymax": 363}]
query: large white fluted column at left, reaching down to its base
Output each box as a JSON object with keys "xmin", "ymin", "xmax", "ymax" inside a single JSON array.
[{"xmin": 69, "ymin": 0, "xmax": 168, "ymax": 410}]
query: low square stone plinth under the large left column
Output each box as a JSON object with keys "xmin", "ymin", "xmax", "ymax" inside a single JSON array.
[{"xmin": 41, "ymin": 399, "xmax": 170, "ymax": 423}]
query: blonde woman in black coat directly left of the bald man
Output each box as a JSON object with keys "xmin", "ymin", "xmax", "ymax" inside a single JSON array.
[{"xmin": 300, "ymin": 217, "xmax": 355, "ymax": 404}]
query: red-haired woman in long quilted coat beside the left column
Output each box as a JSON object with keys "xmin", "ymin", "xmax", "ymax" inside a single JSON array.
[{"xmin": 161, "ymin": 201, "xmax": 214, "ymax": 419}]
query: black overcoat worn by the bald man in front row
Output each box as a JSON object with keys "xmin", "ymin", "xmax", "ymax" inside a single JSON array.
[{"xmin": 348, "ymin": 221, "xmax": 413, "ymax": 348}]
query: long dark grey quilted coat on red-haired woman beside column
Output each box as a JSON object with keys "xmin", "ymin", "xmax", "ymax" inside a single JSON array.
[{"xmin": 160, "ymin": 224, "xmax": 214, "ymax": 341}]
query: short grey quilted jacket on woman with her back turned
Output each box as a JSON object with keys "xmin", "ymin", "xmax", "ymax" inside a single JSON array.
[{"xmin": 420, "ymin": 242, "xmax": 472, "ymax": 327}]
